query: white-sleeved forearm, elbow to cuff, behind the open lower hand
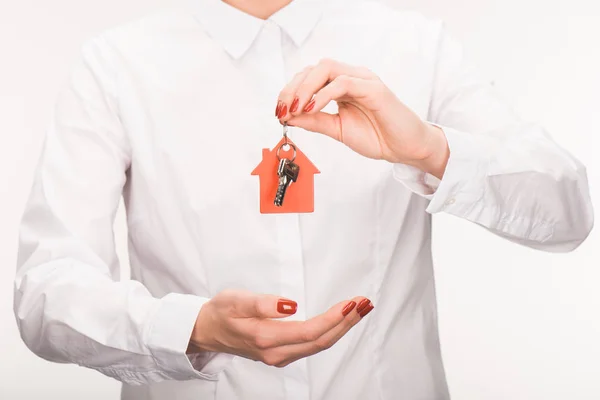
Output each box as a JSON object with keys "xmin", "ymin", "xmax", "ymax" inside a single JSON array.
[{"xmin": 15, "ymin": 253, "xmax": 210, "ymax": 384}]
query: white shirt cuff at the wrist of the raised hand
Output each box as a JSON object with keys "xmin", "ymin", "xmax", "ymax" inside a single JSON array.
[{"xmin": 393, "ymin": 125, "xmax": 495, "ymax": 216}]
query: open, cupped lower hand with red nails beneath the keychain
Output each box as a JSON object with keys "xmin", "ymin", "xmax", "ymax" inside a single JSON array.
[{"xmin": 188, "ymin": 290, "xmax": 374, "ymax": 367}]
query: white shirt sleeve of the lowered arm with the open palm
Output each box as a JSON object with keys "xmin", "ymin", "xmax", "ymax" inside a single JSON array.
[{"xmin": 14, "ymin": 38, "xmax": 228, "ymax": 384}]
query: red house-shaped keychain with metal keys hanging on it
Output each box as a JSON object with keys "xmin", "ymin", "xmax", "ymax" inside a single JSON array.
[{"xmin": 252, "ymin": 125, "xmax": 320, "ymax": 214}]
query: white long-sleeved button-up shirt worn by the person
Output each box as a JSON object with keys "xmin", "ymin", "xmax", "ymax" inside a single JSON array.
[{"xmin": 15, "ymin": 0, "xmax": 593, "ymax": 400}]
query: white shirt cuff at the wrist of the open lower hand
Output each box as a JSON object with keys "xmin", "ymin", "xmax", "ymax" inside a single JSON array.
[{"xmin": 147, "ymin": 293, "xmax": 234, "ymax": 381}]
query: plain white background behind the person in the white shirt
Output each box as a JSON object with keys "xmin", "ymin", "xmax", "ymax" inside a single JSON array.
[{"xmin": 0, "ymin": 0, "xmax": 600, "ymax": 400}]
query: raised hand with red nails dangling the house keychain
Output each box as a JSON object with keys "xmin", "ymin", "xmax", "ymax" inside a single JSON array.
[{"xmin": 275, "ymin": 59, "xmax": 449, "ymax": 178}]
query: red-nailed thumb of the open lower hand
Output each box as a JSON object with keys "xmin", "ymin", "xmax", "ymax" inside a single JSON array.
[{"xmin": 234, "ymin": 292, "xmax": 298, "ymax": 318}]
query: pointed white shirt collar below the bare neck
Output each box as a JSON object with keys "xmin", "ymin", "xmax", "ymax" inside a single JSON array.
[{"xmin": 192, "ymin": 0, "xmax": 325, "ymax": 58}]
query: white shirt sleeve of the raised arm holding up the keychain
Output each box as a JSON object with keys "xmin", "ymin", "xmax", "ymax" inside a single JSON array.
[{"xmin": 394, "ymin": 21, "xmax": 594, "ymax": 252}]
